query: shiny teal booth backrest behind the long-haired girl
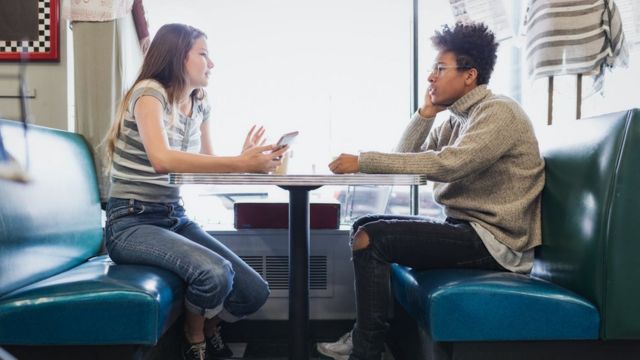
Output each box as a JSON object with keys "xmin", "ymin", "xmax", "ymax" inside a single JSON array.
[{"xmin": 0, "ymin": 119, "xmax": 102, "ymax": 296}]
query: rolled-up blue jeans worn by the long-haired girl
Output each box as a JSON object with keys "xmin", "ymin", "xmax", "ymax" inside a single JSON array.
[{"xmin": 106, "ymin": 198, "xmax": 269, "ymax": 322}]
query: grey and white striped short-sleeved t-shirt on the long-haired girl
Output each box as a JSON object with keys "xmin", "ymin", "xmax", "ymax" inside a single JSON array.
[{"xmin": 110, "ymin": 80, "xmax": 210, "ymax": 202}]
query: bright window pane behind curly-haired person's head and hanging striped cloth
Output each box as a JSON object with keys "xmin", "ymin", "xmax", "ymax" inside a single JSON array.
[{"xmin": 419, "ymin": 0, "xmax": 640, "ymax": 127}]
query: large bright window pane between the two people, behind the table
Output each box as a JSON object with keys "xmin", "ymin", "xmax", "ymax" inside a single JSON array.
[{"xmin": 145, "ymin": 0, "xmax": 430, "ymax": 226}]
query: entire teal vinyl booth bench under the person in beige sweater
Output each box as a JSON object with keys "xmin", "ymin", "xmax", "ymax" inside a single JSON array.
[{"xmin": 390, "ymin": 109, "xmax": 640, "ymax": 359}]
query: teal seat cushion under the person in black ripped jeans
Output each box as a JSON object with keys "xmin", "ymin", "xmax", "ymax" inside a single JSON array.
[{"xmin": 391, "ymin": 264, "xmax": 600, "ymax": 341}]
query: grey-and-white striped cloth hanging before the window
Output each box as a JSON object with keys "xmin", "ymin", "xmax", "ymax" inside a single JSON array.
[{"xmin": 525, "ymin": 0, "xmax": 628, "ymax": 85}]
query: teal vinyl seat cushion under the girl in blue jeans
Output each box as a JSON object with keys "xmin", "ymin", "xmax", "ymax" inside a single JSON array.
[{"xmin": 0, "ymin": 256, "xmax": 184, "ymax": 345}]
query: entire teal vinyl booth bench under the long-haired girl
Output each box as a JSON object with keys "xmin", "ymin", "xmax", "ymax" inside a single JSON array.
[{"xmin": 0, "ymin": 119, "xmax": 184, "ymax": 356}]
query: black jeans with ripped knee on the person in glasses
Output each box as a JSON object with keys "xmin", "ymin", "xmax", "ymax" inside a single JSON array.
[{"xmin": 349, "ymin": 215, "xmax": 505, "ymax": 360}]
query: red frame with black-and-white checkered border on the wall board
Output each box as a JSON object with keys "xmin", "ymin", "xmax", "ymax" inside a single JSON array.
[{"xmin": 0, "ymin": 0, "xmax": 59, "ymax": 60}]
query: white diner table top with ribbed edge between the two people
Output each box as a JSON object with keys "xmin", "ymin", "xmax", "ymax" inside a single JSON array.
[{"xmin": 169, "ymin": 173, "xmax": 427, "ymax": 186}]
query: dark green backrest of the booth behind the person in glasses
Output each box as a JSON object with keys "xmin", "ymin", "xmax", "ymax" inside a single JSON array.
[{"xmin": 532, "ymin": 109, "xmax": 640, "ymax": 339}]
